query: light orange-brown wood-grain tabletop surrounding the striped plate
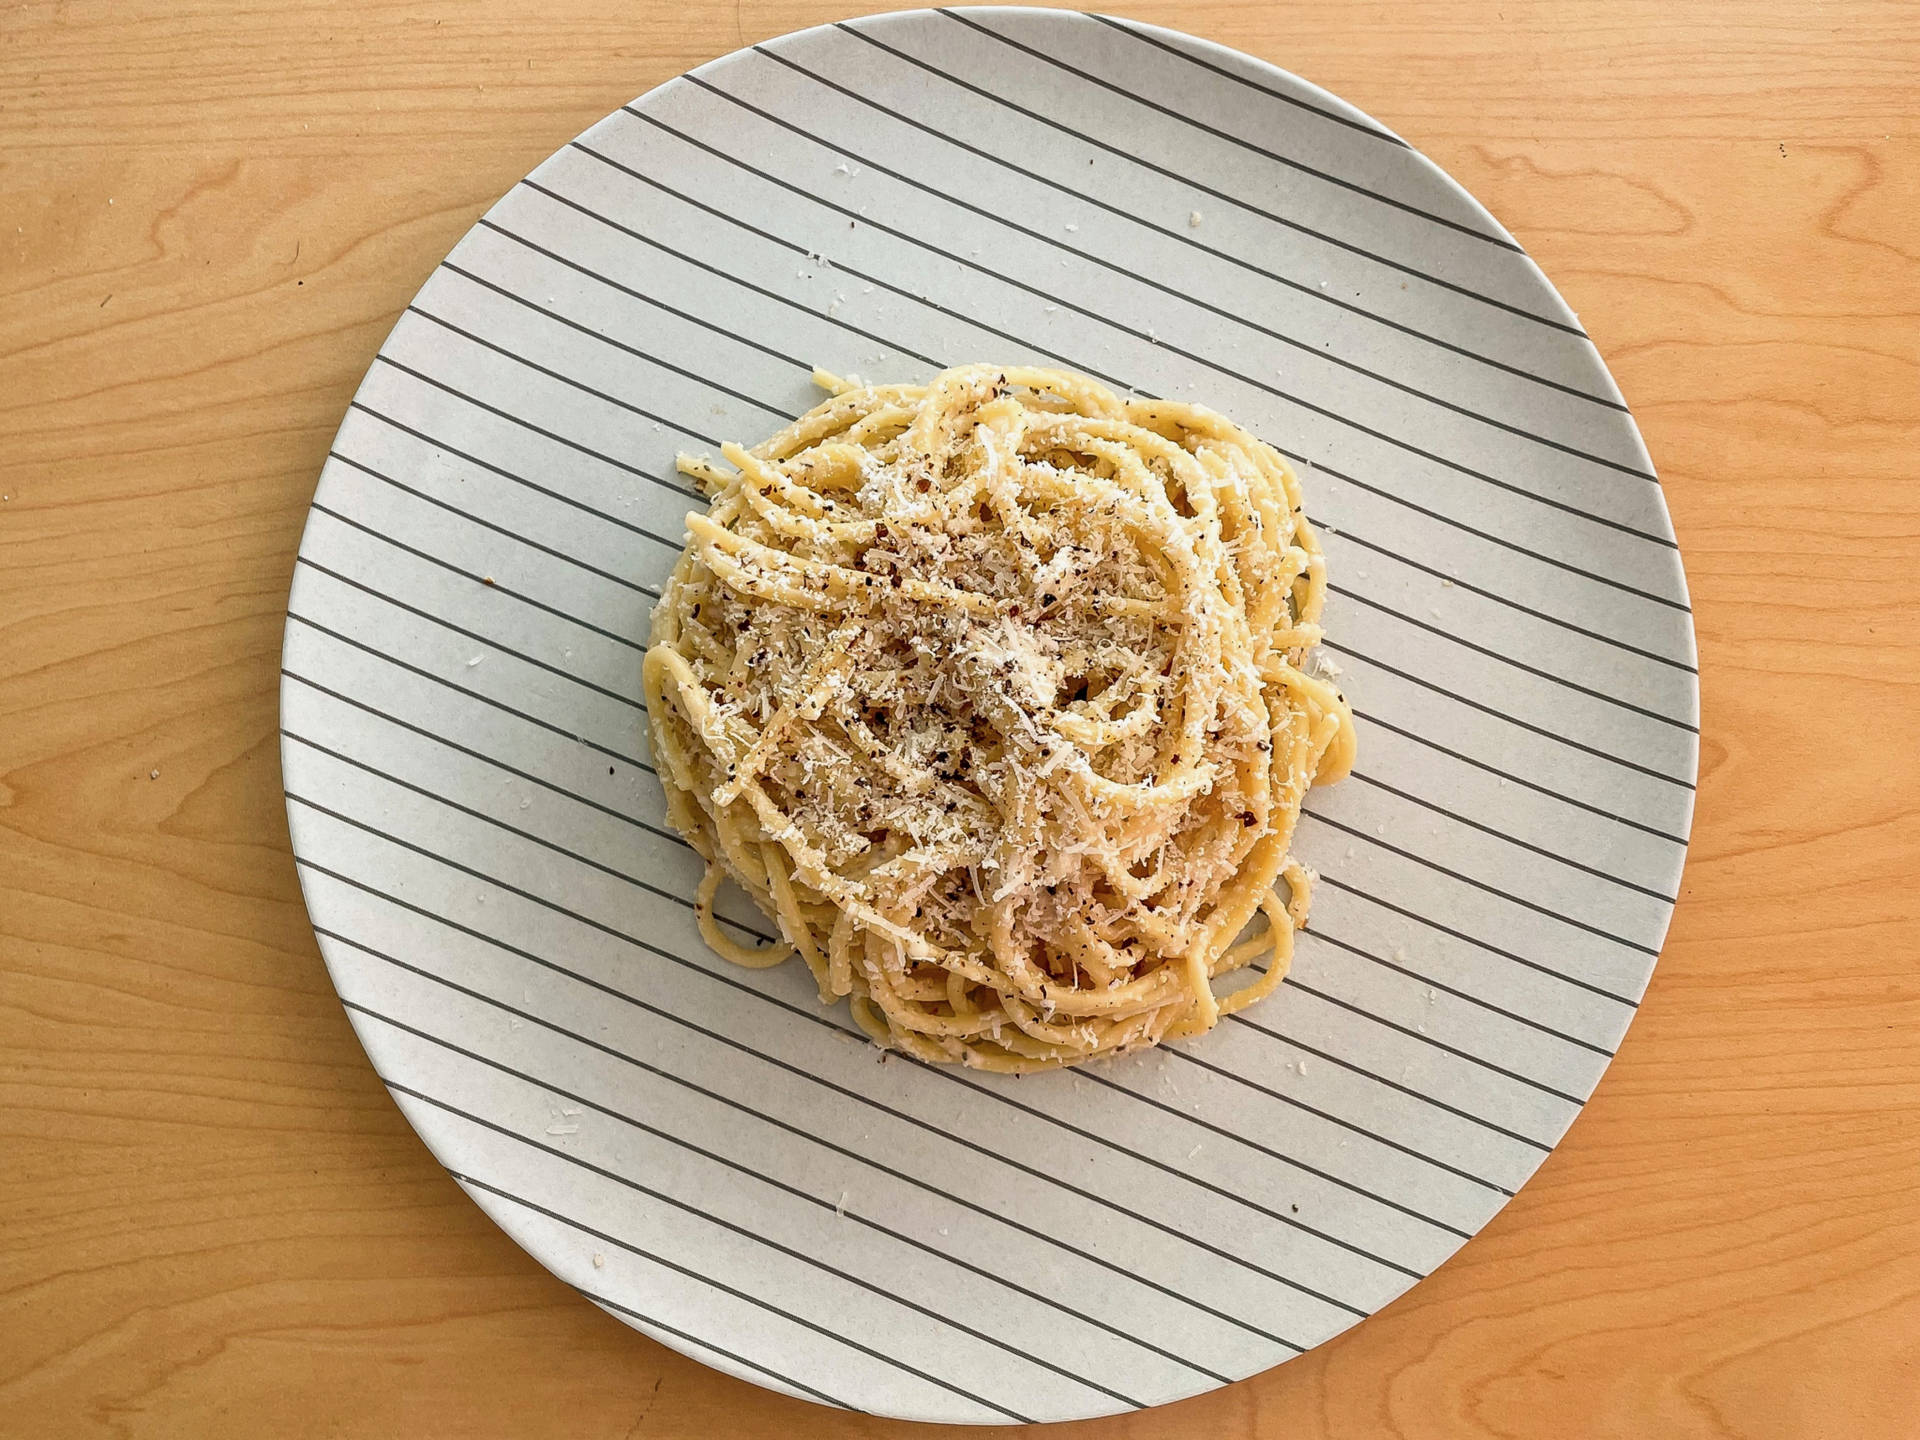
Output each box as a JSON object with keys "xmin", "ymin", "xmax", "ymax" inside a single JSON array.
[{"xmin": 0, "ymin": 0, "xmax": 1920, "ymax": 1440}]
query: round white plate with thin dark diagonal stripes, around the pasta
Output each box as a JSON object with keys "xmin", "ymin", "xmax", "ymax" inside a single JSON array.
[{"xmin": 280, "ymin": 10, "xmax": 1697, "ymax": 1421}]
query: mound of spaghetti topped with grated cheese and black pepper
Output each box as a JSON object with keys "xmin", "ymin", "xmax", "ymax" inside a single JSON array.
[{"xmin": 643, "ymin": 365, "xmax": 1354, "ymax": 1073}]
